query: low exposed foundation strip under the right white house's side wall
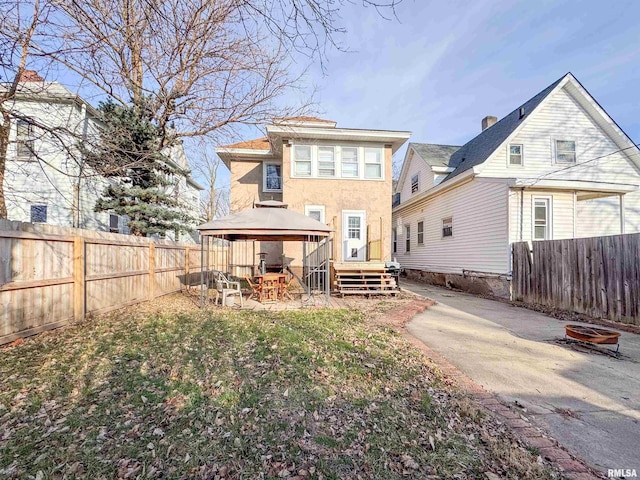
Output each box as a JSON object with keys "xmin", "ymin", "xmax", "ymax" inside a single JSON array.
[{"xmin": 405, "ymin": 269, "xmax": 511, "ymax": 299}]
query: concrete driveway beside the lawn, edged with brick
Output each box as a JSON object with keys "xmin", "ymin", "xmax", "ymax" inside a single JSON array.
[{"xmin": 402, "ymin": 281, "xmax": 640, "ymax": 476}]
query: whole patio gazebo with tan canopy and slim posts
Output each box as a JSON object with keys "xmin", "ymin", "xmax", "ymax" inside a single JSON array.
[{"xmin": 197, "ymin": 200, "xmax": 332, "ymax": 304}]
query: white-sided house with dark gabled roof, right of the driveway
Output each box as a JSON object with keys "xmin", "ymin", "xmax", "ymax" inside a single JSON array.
[{"xmin": 392, "ymin": 73, "xmax": 640, "ymax": 295}]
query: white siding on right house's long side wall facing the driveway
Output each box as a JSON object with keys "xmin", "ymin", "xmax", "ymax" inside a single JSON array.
[{"xmin": 392, "ymin": 180, "xmax": 509, "ymax": 274}]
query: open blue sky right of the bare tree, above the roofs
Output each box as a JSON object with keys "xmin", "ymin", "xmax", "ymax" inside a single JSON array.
[{"xmin": 215, "ymin": 0, "xmax": 640, "ymax": 187}]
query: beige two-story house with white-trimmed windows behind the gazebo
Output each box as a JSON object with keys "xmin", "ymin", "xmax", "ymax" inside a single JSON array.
[{"xmin": 216, "ymin": 117, "xmax": 410, "ymax": 274}]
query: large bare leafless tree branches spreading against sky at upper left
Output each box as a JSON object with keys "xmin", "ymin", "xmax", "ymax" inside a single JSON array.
[{"xmin": 0, "ymin": 0, "xmax": 401, "ymax": 221}]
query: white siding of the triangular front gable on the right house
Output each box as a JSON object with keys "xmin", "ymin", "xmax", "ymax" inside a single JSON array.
[{"xmin": 479, "ymin": 84, "xmax": 640, "ymax": 184}]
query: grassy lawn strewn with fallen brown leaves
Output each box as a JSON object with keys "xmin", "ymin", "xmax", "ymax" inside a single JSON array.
[{"xmin": 0, "ymin": 295, "xmax": 555, "ymax": 480}]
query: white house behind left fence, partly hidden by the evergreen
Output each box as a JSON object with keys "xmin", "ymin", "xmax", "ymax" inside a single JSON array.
[{"xmin": 0, "ymin": 70, "xmax": 203, "ymax": 242}]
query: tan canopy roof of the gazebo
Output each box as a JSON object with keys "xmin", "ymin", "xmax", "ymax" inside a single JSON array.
[{"xmin": 197, "ymin": 202, "xmax": 332, "ymax": 241}]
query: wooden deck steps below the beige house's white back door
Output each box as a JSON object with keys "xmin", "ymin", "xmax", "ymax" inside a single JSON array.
[{"xmin": 333, "ymin": 262, "xmax": 398, "ymax": 296}]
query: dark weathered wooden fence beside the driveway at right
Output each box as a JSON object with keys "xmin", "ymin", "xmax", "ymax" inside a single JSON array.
[{"xmin": 511, "ymin": 234, "xmax": 640, "ymax": 325}]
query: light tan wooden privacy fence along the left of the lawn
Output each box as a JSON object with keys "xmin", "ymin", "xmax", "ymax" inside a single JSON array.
[{"xmin": 0, "ymin": 220, "xmax": 230, "ymax": 344}]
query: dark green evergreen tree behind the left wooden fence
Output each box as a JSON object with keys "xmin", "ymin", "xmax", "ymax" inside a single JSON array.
[{"xmin": 83, "ymin": 101, "xmax": 195, "ymax": 236}]
